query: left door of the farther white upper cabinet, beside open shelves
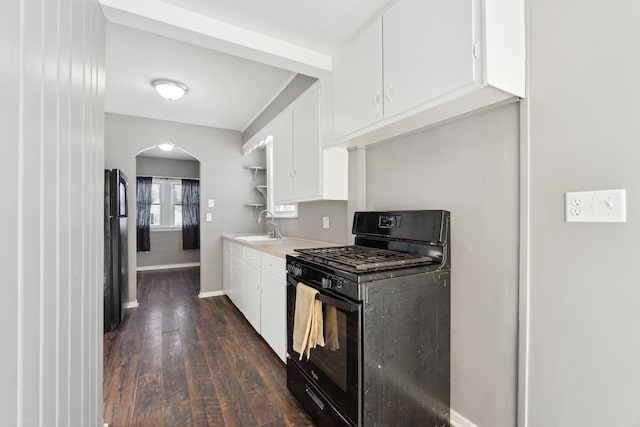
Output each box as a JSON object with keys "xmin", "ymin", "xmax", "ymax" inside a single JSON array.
[{"xmin": 271, "ymin": 112, "xmax": 293, "ymax": 203}]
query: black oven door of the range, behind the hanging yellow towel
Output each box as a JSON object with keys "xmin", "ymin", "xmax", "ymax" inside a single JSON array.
[{"xmin": 287, "ymin": 274, "xmax": 362, "ymax": 424}]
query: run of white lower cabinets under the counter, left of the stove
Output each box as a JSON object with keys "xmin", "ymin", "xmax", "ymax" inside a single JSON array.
[{"xmin": 222, "ymin": 240, "xmax": 287, "ymax": 362}]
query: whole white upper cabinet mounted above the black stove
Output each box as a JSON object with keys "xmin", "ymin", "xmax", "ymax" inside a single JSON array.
[{"xmin": 329, "ymin": 0, "xmax": 525, "ymax": 146}]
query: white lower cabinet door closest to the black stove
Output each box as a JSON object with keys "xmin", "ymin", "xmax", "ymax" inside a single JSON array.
[{"xmin": 261, "ymin": 271, "xmax": 287, "ymax": 362}]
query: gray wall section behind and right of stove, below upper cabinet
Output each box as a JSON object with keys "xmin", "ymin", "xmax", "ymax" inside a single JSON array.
[{"xmin": 360, "ymin": 104, "xmax": 520, "ymax": 427}]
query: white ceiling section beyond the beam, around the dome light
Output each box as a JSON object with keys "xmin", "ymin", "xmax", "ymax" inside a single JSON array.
[{"xmin": 105, "ymin": 24, "xmax": 295, "ymax": 131}]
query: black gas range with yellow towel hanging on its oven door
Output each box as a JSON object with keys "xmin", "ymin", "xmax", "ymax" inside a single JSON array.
[{"xmin": 287, "ymin": 210, "xmax": 451, "ymax": 426}]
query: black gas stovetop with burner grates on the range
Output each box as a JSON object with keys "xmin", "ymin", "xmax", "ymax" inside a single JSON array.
[{"xmin": 295, "ymin": 246, "xmax": 434, "ymax": 273}]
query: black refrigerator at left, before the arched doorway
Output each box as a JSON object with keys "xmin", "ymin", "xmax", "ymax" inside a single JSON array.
[{"xmin": 104, "ymin": 169, "xmax": 129, "ymax": 333}]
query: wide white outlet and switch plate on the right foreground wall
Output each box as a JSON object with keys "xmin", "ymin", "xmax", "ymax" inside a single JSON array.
[{"xmin": 564, "ymin": 189, "xmax": 627, "ymax": 222}]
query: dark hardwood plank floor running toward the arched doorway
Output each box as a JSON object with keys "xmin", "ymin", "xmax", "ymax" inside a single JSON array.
[{"xmin": 103, "ymin": 268, "xmax": 313, "ymax": 427}]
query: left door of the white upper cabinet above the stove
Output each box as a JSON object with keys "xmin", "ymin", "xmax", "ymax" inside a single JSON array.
[{"xmin": 333, "ymin": 19, "xmax": 382, "ymax": 139}]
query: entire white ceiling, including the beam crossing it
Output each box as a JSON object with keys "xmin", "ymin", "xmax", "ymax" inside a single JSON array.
[{"xmin": 99, "ymin": 0, "xmax": 390, "ymax": 157}]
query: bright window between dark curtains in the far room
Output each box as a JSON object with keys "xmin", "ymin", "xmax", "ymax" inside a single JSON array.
[{"xmin": 151, "ymin": 178, "xmax": 182, "ymax": 227}]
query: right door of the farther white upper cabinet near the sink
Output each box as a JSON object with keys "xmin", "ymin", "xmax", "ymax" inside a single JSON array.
[{"xmin": 293, "ymin": 86, "xmax": 322, "ymax": 199}]
